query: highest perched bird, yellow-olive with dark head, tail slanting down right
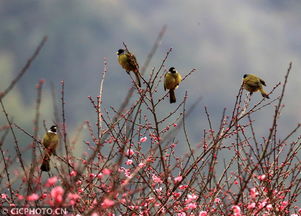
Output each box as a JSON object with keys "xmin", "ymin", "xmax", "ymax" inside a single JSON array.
[{"xmin": 117, "ymin": 49, "xmax": 141, "ymax": 87}]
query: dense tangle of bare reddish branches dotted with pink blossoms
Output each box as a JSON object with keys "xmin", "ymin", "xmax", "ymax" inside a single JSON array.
[{"xmin": 0, "ymin": 32, "xmax": 301, "ymax": 216}]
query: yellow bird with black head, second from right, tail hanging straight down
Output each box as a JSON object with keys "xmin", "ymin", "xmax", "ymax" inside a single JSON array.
[{"xmin": 164, "ymin": 67, "xmax": 182, "ymax": 103}]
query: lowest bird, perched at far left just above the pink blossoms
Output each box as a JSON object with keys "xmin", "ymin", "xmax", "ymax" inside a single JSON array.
[{"xmin": 41, "ymin": 125, "xmax": 59, "ymax": 172}]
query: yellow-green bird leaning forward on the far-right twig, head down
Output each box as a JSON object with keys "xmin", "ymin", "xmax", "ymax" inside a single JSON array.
[{"xmin": 243, "ymin": 74, "xmax": 269, "ymax": 98}]
